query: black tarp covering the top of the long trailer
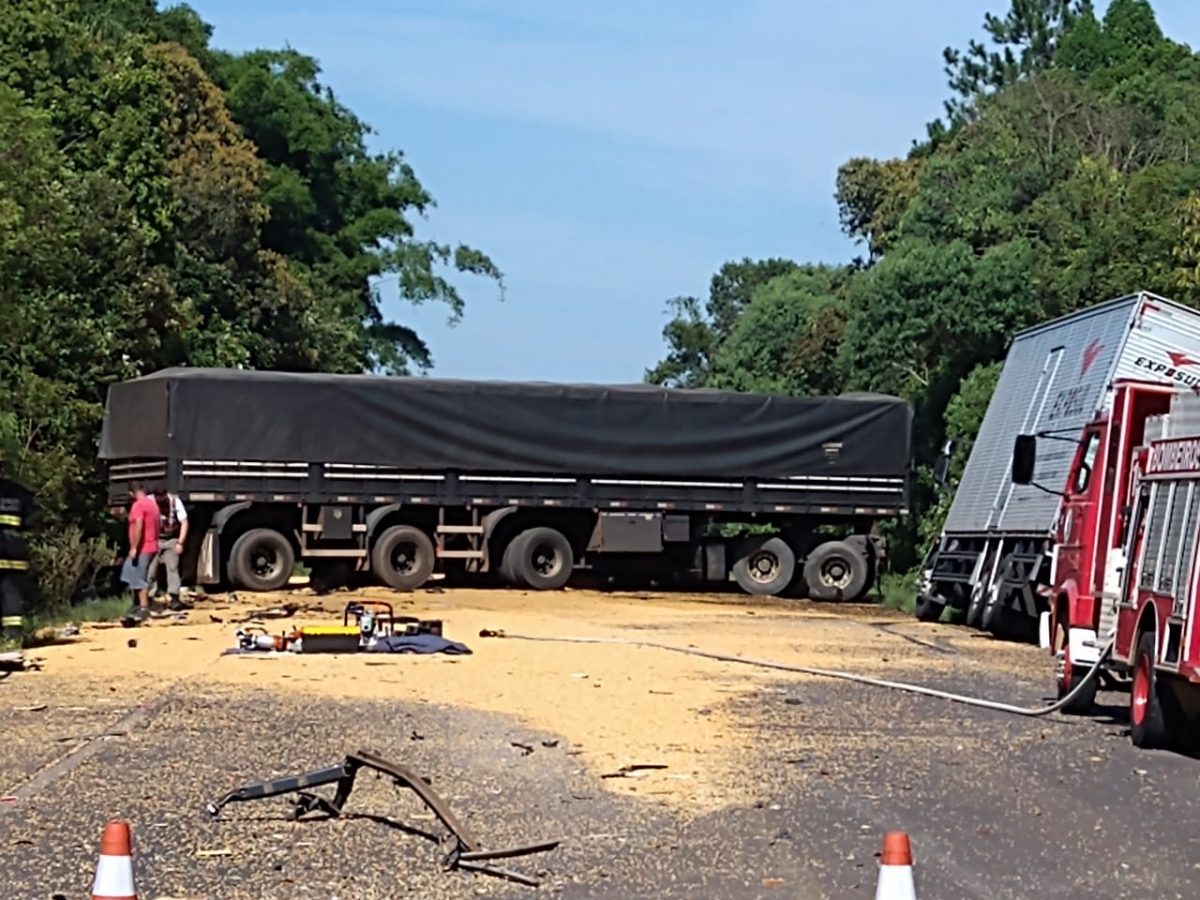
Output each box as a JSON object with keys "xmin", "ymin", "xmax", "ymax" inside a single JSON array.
[{"xmin": 100, "ymin": 368, "xmax": 912, "ymax": 478}]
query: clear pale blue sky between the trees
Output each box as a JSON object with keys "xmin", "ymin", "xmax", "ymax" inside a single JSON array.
[{"xmin": 184, "ymin": 0, "xmax": 1200, "ymax": 382}]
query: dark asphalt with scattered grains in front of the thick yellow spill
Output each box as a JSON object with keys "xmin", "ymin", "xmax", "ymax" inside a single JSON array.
[{"xmin": 0, "ymin": 625, "xmax": 1200, "ymax": 900}]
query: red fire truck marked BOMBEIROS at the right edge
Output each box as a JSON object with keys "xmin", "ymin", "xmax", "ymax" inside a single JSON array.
[{"xmin": 1013, "ymin": 382, "xmax": 1200, "ymax": 746}]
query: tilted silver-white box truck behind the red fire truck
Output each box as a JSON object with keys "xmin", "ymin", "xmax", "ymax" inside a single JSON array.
[{"xmin": 917, "ymin": 293, "xmax": 1200, "ymax": 636}]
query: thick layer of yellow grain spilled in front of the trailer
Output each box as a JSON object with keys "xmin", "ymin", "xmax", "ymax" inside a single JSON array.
[{"xmin": 7, "ymin": 590, "xmax": 1028, "ymax": 814}]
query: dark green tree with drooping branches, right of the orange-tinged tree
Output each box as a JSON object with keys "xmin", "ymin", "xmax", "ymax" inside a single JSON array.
[{"xmin": 214, "ymin": 50, "xmax": 502, "ymax": 372}]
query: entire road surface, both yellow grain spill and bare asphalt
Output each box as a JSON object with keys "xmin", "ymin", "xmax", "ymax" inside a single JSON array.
[{"xmin": 0, "ymin": 589, "xmax": 1200, "ymax": 899}]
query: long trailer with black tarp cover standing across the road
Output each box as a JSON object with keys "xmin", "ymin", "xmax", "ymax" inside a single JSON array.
[{"xmin": 100, "ymin": 368, "xmax": 912, "ymax": 600}]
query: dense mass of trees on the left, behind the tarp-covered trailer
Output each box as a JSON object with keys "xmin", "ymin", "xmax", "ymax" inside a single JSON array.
[{"xmin": 0, "ymin": 0, "xmax": 499, "ymax": 609}]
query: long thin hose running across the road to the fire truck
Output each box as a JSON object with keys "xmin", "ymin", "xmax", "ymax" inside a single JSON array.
[{"xmin": 479, "ymin": 629, "xmax": 1112, "ymax": 718}]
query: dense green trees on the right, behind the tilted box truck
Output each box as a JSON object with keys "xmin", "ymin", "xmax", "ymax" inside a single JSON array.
[{"xmin": 647, "ymin": 0, "xmax": 1200, "ymax": 565}]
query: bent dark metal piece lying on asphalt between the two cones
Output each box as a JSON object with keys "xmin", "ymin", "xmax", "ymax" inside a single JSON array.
[{"xmin": 206, "ymin": 750, "xmax": 561, "ymax": 887}]
